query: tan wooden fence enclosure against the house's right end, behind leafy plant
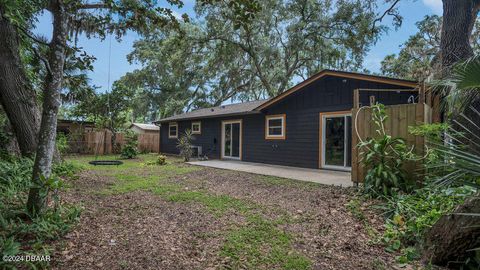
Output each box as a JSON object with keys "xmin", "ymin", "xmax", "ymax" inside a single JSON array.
[{"xmin": 352, "ymin": 90, "xmax": 432, "ymax": 183}]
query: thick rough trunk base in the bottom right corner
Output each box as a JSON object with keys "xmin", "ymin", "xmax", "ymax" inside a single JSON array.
[{"xmin": 425, "ymin": 196, "xmax": 480, "ymax": 265}]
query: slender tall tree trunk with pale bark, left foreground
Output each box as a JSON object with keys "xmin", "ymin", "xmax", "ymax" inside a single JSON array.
[{"xmin": 27, "ymin": 0, "xmax": 68, "ymax": 215}]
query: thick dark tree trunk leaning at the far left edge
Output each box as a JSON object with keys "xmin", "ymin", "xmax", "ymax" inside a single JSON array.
[{"xmin": 0, "ymin": 6, "xmax": 40, "ymax": 156}]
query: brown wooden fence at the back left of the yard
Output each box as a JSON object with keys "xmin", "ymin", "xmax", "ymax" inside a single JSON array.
[{"xmin": 69, "ymin": 131, "xmax": 160, "ymax": 155}]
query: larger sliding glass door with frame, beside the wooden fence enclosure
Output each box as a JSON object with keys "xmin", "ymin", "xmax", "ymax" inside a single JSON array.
[{"xmin": 320, "ymin": 113, "xmax": 352, "ymax": 171}]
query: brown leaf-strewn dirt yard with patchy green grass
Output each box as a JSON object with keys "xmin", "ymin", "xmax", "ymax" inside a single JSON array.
[{"xmin": 53, "ymin": 155, "xmax": 395, "ymax": 269}]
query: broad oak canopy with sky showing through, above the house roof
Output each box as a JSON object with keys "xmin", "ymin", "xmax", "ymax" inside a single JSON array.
[{"xmin": 121, "ymin": 0, "xmax": 385, "ymax": 120}]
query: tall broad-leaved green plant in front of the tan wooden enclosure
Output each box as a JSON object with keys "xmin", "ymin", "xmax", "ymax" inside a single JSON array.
[{"xmin": 358, "ymin": 104, "xmax": 414, "ymax": 197}]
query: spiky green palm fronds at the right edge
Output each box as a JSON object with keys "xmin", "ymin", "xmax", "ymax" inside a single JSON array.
[{"xmin": 430, "ymin": 53, "xmax": 480, "ymax": 188}]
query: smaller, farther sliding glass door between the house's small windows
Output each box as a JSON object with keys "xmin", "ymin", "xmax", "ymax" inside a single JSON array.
[{"xmin": 222, "ymin": 120, "xmax": 242, "ymax": 159}]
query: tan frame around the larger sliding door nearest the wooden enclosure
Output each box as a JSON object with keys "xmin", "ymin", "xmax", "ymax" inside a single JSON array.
[{"xmin": 320, "ymin": 111, "xmax": 352, "ymax": 171}]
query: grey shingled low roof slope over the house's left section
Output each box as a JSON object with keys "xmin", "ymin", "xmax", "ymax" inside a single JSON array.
[{"xmin": 156, "ymin": 99, "xmax": 268, "ymax": 123}]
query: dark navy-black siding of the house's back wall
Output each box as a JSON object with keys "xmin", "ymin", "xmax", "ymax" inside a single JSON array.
[{"xmin": 161, "ymin": 76, "xmax": 416, "ymax": 168}]
